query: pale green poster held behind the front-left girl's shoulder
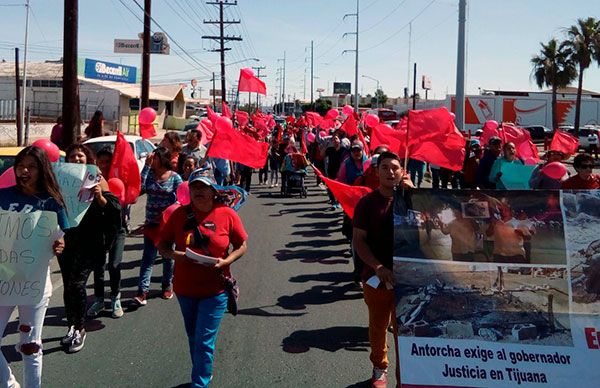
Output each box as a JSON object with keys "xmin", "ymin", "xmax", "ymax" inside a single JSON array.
[{"xmin": 52, "ymin": 163, "xmax": 100, "ymax": 228}]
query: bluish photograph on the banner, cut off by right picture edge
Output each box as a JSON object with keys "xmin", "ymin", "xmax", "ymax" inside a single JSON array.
[{"xmin": 562, "ymin": 190, "xmax": 600, "ymax": 314}]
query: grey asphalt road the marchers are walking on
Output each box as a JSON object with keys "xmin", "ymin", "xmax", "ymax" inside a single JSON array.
[{"xmin": 2, "ymin": 175, "xmax": 395, "ymax": 387}]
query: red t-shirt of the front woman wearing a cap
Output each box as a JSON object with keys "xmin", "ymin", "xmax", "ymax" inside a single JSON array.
[{"xmin": 161, "ymin": 205, "xmax": 248, "ymax": 298}]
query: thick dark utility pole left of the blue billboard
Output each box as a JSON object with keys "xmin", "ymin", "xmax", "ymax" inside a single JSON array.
[{"xmin": 62, "ymin": 0, "xmax": 81, "ymax": 147}]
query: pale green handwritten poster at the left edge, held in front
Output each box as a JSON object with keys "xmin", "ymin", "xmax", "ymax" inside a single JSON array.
[{"xmin": 0, "ymin": 210, "xmax": 58, "ymax": 306}]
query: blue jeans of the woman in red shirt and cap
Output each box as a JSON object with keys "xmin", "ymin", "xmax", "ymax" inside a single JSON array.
[{"xmin": 177, "ymin": 292, "xmax": 227, "ymax": 387}]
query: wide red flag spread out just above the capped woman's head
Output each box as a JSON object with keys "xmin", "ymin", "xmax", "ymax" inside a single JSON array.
[{"xmin": 208, "ymin": 119, "xmax": 269, "ymax": 168}]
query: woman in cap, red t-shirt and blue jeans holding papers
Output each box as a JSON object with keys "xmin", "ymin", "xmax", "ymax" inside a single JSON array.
[{"xmin": 158, "ymin": 169, "xmax": 248, "ymax": 387}]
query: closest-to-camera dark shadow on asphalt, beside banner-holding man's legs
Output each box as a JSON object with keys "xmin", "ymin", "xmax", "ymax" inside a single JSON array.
[{"xmin": 282, "ymin": 326, "xmax": 369, "ymax": 353}]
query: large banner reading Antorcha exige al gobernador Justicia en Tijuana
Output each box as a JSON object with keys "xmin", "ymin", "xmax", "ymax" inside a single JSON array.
[{"xmin": 394, "ymin": 190, "xmax": 600, "ymax": 388}]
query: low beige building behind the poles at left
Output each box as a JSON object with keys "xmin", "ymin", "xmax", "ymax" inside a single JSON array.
[{"xmin": 0, "ymin": 61, "xmax": 186, "ymax": 133}]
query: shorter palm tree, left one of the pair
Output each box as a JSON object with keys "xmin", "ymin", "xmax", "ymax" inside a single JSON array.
[{"xmin": 531, "ymin": 38, "xmax": 577, "ymax": 130}]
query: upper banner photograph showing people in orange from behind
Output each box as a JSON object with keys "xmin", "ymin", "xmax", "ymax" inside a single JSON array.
[{"xmin": 394, "ymin": 190, "xmax": 566, "ymax": 265}]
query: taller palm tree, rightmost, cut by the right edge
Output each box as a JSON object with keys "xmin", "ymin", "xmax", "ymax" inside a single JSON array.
[{"xmin": 563, "ymin": 17, "xmax": 600, "ymax": 134}]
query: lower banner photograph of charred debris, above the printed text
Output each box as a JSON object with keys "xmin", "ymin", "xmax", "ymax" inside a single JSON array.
[{"xmin": 394, "ymin": 258, "xmax": 573, "ymax": 346}]
